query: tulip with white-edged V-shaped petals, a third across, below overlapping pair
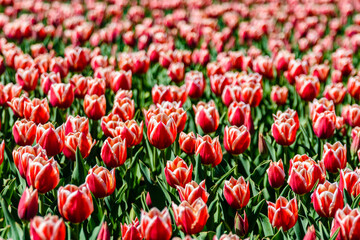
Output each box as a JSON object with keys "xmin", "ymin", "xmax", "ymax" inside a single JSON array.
[{"xmin": 101, "ymin": 136, "xmax": 126, "ymax": 168}]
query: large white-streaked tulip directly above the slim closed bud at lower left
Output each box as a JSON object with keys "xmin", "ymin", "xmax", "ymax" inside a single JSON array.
[{"xmin": 26, "ymin": 156, "xmax": 60, "ymax": 193}]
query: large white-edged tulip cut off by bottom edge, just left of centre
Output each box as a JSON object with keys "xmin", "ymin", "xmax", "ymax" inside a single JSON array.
[{"xmin": 140, "ymin": 208, "xmax": 172, "ymax": 240}]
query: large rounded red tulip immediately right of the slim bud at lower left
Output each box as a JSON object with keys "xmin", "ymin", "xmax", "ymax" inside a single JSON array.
[{"xmin": 58, "ymin": 184, "xmax": 94, "ymax": 223}]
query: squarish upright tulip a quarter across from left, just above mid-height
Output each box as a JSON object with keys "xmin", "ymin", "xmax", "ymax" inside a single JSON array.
[{"xmin": 84, "ymin": 95, "xmax": 106, "ymax": 120}]
